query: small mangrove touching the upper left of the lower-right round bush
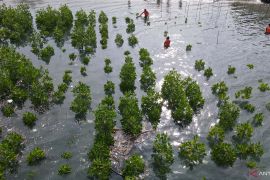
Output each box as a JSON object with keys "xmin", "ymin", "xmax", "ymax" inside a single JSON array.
[{"xmin": 207, "ymin": 125, "xmax": 225, "ymax": 148}]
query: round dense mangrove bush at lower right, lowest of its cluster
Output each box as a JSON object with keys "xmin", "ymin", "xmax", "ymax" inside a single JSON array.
[{"xmin": 211, "ymin": 142, "xmax": 236, "ymax": 167}]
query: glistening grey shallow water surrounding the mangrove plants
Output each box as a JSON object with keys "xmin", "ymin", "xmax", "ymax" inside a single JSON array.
[{"xmin": 0, "ymin": 0, "xmax": 270, "ymax": 180}]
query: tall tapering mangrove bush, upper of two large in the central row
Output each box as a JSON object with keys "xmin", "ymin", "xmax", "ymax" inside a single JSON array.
[{"xmin": 120, "ymin": 56, "xmax": 136, "ymax": 93}]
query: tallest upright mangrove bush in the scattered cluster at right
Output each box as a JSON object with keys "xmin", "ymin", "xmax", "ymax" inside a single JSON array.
[{"xmin": 218, "ymin": 101, "xmax": 240, "ymax": 131}]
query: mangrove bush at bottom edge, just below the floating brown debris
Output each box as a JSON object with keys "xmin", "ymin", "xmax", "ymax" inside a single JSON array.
[{"xmin": 123, "ymin": 154, "xmax": 145, "ymax": 179}]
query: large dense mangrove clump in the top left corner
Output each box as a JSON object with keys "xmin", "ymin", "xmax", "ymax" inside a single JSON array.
[{"xmin": 0, "ymin": 4, "xmax": 33, "ymax": 45}]
